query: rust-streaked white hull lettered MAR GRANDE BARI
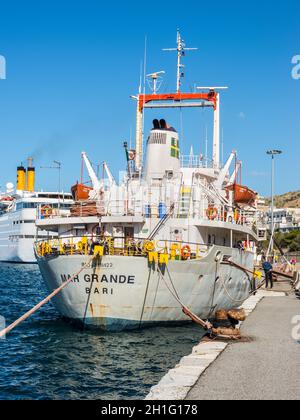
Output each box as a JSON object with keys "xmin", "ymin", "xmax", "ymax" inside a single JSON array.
[{"xmin": 38, "ymin": 246, "xmax": 254, "ymax": 331}]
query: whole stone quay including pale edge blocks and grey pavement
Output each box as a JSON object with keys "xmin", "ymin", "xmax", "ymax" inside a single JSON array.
[{"xmin": 146, "ymin": 279, "xmax": 300, "ymax": 401}]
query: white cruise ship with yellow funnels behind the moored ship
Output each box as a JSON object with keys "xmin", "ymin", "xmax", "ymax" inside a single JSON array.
[{"xmin": 0, "ymin": 159, "xmax": 73, "ymax": 263}]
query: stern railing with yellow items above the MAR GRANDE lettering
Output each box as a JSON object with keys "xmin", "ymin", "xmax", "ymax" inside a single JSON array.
[{"xmin": 35, "ymin": 235, "xmax": 213, "ymax": 261}]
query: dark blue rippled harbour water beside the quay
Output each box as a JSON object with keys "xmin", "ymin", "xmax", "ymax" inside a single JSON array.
[{"xmin": 0, "ymin": 264, "xmax": 201, "ymax": 399}]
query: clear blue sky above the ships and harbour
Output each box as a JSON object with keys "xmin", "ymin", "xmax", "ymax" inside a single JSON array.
[{"xmin": 0, "ymin": 0, "xmax": 300, "ymax": 195}]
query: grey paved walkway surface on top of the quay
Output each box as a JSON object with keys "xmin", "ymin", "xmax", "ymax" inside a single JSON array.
[{"xmin": 187, "ymin": 284, "xmax": 300, "ymax": 400}]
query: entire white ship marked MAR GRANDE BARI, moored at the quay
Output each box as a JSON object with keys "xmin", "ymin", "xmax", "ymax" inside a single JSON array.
[{"xmin": 36, "ymin": 32, "xmax": 257, "ymax": 331}]
